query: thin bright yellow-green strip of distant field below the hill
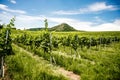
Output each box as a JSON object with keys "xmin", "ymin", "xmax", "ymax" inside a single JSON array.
[{"xmin": 13, "ymin": 30, "xmax": 120, "ymax": 37}]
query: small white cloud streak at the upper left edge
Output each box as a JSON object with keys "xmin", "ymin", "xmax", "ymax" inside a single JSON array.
[{"xmin": 0, "ymin": 4, "xmax": 26, "ymax": 14}]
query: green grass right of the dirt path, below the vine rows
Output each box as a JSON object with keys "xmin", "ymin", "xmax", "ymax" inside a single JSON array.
[{"xmin": 15, "ymin": 43, "xmax": 120, "ymax": 80}]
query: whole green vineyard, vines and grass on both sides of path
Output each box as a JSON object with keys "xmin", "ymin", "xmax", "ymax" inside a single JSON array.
[{"xmin": 0, "ymin": 25, "xmax": 120, "ymax": 80}]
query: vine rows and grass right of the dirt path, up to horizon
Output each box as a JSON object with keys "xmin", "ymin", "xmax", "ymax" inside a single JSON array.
[{"xmin": 11, "ymin": 31, "xmax": 120, "ymax": 80}]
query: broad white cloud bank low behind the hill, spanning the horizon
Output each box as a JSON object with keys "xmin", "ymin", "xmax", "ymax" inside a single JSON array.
[{"xmin": 0, "ymin": 12, "xmax": 120, "ymax": 31}]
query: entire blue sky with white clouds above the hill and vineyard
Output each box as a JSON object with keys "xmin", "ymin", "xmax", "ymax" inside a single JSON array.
[{"xmin": 0, "ymin": 0, "xmax": 120, "ymax": 31}]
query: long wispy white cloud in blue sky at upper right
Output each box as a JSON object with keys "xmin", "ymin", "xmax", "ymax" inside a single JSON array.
[{"xmin": 53, "ymin": 2, "xmax": 117, "ymax": 15}]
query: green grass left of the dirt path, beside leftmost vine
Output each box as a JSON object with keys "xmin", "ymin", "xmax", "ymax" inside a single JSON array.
[{"xmin": 5, "ymin": 45, "xmax": 67, "ymax": 80}]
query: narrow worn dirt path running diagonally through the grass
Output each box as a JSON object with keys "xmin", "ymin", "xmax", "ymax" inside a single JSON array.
[{"xmin": 13, "ymin": 44, "xmax": 80, "ymax": 80}]
